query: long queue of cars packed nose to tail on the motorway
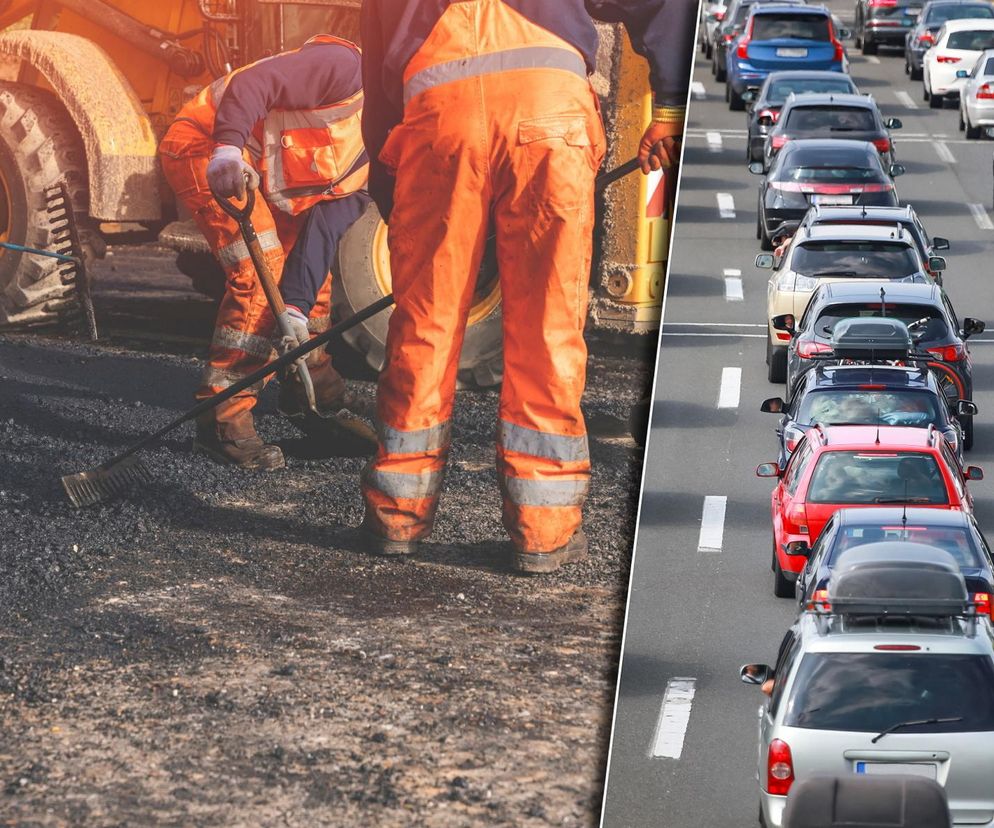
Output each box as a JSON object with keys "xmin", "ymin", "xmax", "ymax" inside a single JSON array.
[{"xmin": 702, "ymin": 6, "xmax": 994, "ymax": 828}]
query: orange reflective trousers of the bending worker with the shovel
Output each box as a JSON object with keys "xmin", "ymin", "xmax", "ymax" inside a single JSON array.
[{"xmin": 159, "ymin": 120, "xmax": 331, "ymax": 421}]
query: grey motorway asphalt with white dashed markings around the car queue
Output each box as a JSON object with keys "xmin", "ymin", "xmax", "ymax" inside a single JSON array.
[{"xmin": 604, "ymin": 2, "xmax": 994, "ymax": 828}]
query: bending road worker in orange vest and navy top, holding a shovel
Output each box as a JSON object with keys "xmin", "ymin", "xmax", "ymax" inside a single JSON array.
[{"xmin": 159, "ymin": 35, "xmax": 375, "ymax": 469}]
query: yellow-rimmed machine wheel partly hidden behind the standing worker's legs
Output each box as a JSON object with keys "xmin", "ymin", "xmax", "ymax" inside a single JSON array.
[{"xmin": 332, "ymin": 204, "xmax": 503, "ymax": 386}]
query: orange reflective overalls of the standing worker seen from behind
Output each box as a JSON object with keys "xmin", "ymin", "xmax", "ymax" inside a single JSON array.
[{"xmin": 362, "ymin": 0, "xmax": 605, "ymax": 552}]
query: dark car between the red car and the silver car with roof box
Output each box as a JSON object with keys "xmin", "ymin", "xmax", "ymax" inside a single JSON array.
[{"xmin": 793, "ymin": 506, "xmax": 994, "ymax": 615}]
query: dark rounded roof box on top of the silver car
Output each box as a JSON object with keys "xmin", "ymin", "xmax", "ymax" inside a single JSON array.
[{"xmin": 828, "ymin": 541, "xmax": 970, "ymax": 616}]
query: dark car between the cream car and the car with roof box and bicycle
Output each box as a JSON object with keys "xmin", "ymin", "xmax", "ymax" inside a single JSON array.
[{"xmin": 773, "ymin": 280, "xmax": 985, "ymax": 449}]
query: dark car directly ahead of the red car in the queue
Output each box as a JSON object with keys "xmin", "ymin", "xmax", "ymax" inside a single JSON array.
[{"xmin": 760, "ymin": 363, "xmax": 977, "ymax": 468}]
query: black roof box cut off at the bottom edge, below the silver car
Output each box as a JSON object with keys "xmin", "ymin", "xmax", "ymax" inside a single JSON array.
[{"xmin": 783, "ymin": 774, "xmax": 952, "ymax": 828}]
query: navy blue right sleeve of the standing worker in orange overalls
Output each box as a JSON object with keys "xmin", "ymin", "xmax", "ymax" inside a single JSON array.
[{"xmin": 585, "ymin": 0, "xmax": 697, "ymax": 106}]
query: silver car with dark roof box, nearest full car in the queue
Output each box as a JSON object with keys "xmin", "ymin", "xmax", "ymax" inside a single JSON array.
[{"xmin": 741, "ymin": 544, "xmax": 994, "ymax": 828}]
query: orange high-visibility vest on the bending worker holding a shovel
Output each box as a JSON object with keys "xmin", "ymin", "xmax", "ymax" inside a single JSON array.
[{"xmin": 180, "ymin": 35, "xmax": 369, "ymax": 216}]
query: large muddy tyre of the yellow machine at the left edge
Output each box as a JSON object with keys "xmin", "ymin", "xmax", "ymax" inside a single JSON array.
[{"xmin": 0, "ymin": 81, "xmax": 104, "ymax": 330}]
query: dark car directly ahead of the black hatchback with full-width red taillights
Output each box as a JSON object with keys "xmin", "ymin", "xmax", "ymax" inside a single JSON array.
[{"xmin": 764, "ymin": 92, "xmax": 903, "ymax": 169}]
